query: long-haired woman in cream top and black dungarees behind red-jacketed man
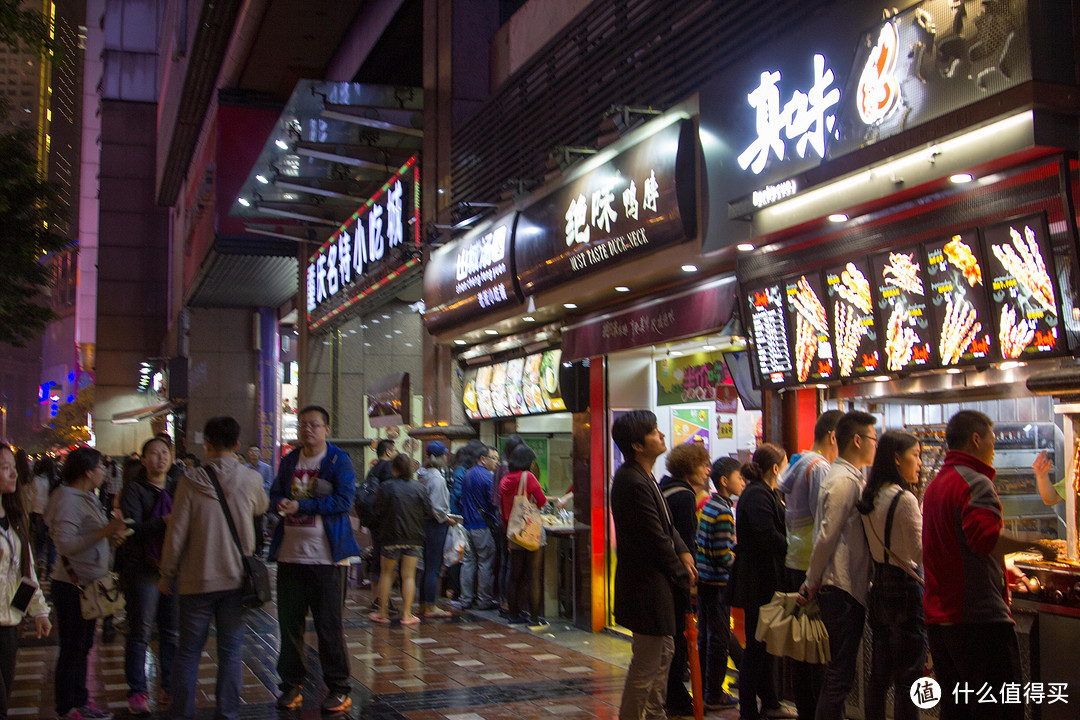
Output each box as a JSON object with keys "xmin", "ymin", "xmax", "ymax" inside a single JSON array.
[{"xmin": 855, "ymin": 430, "xmax": 927, "ymax": 720}]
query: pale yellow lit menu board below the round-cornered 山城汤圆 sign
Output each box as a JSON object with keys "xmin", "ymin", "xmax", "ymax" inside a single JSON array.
[{"xmin": 462, "ymin": 350, "xmax": 566, "ymax": 420}]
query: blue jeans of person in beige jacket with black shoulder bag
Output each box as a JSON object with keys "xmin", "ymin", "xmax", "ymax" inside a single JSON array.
[{"xmin": 167, "ymin": 588, "xmax": 244, "ymax": 720}]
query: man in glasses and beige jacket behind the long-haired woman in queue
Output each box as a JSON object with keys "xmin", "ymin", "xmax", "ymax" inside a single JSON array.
[{"xmin": 799, "ymin": 410, "xmax": 877, "ymax": 720}]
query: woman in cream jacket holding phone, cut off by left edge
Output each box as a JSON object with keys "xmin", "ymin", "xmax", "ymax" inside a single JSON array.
[{"xmin": 0, "ymin": 443, "xmax": 52, "ymax": 718}]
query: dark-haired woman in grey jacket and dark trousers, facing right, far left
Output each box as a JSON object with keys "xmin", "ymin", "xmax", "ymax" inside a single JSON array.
[{"xmin": 45, "ymin": 448, "xmax": 127, "ymax": 720}]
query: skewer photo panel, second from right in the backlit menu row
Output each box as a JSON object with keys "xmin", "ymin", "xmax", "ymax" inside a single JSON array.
[{"xmin": 923, "ymin": 230, "xmax": 995, "ymax": 367}]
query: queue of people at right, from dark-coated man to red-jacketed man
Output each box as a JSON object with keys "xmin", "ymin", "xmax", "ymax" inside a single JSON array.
[{"xmin": 610, "ymin": 410, "xmax": 1055, "ymax": 720}]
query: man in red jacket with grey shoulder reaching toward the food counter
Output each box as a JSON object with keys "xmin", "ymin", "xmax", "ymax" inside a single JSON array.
[{"xmin": 922, "ymin": 410, "xmax": 1055, "ymax": 720}]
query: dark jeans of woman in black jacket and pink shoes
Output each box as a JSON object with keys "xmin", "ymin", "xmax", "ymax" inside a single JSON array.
[{"xmin": 124, "ymin": 575, "xmax": 178, "ymax": 697}]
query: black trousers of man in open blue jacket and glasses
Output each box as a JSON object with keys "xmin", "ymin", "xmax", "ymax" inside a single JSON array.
[{"xmin": 278, "ymin": 562, "xmax": 352, "ymax": 694}]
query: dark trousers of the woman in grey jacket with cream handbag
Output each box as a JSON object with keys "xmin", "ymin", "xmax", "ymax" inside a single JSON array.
[{"xmin": 53, "ymin": 580, "xmax": 97, "ymax": 715}]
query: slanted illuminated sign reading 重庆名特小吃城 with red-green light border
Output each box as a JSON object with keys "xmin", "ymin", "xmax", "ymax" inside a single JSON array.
[{"xmin": 306, "ymin": 157, "xmax": 420, "ymax": 327}]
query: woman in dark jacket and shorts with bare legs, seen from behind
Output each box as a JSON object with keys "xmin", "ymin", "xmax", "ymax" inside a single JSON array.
[{"xmin": 368, "ymin": 453, "xmax": 434, "ymax": 625}]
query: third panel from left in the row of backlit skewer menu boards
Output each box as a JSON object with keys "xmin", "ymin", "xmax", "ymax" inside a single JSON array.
[{"xmin": 825, "ymin": 258, "xmax": 885, "ymax": 378}]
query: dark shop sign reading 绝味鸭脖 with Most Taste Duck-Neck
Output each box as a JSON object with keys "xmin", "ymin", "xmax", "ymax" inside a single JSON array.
[{"xmin": 514, "ymin": 120, "xmax": 697, "ymax": 295}]
